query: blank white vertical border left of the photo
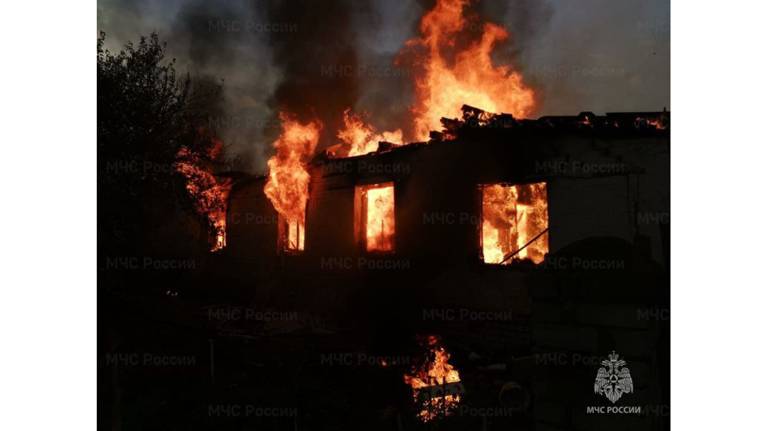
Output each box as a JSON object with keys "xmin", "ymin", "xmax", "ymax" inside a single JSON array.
[{"xmin": 0, "ymin": 1, "xmax": 97, "ymax": 430}]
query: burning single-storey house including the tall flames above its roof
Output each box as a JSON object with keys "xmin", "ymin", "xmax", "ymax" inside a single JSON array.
[{"xmin": 216, "ymin": 0, "xmax": 669, "ymax": 294}]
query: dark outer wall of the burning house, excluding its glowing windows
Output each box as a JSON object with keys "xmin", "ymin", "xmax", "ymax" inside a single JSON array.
[{"xmin": 228, "ymin": 130, "xmax": 669, "ymax": 265}]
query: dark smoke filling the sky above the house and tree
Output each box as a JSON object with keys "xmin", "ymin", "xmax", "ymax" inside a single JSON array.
[{"xmin": 98, "ymin": 0, "xmax": 669, "ymax": 172}]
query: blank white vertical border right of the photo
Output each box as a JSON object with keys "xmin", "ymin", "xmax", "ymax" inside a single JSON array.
[{"xmin": 671, "ymin": 1, "xmax": 768, "ymax": 430}]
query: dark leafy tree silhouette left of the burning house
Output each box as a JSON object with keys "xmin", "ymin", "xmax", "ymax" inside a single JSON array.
[{"xmin": 97, "ymin": 33, "xmax": 221, "ymax": 257}]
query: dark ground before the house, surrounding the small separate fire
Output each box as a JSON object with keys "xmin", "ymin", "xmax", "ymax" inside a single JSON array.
[{"xmin": 98, "ymin": 258, "xmax": 533, "ymax": 430}]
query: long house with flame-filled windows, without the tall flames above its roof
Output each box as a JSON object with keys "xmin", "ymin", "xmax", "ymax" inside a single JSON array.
[{"xmin": 227, "ymin": 106, "xmax": 669, "ymax": 278}]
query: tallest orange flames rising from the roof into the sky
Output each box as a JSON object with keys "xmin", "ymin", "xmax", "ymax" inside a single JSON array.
[{"xmin": 331, "ymin": 0, "xmax": 535, "ymax": 157}]
